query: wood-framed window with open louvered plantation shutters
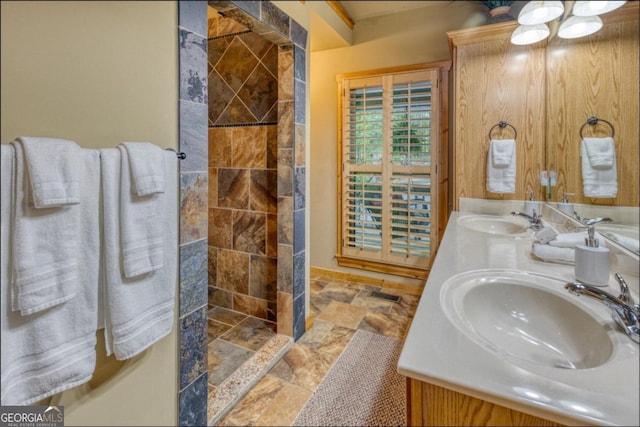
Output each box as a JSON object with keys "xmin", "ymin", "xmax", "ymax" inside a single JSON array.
[{"xmin": 338, "ymin": 69, "xmax": 439, "ymax": 277}]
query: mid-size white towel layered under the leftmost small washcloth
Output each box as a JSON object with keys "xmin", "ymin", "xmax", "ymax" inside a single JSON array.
[{"xmin": 11, "ymin": 140, "xmax": 80, "ymax": 316}]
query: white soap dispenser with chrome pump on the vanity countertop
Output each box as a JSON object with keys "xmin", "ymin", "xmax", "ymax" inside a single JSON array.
[{"xmin": 575, "ymin": 224, "xmax": 609, "ymax": 286}]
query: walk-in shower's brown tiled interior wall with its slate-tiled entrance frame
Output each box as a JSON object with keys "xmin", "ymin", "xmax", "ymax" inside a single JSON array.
[{"xmin": 178, "ymin": 0, "xmax": 307, "ymax": 425}]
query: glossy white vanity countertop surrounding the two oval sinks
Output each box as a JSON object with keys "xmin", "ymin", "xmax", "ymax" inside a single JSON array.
[{"xmin": 398, "ymin": 203, "xmax": 640, "ymax": 425}]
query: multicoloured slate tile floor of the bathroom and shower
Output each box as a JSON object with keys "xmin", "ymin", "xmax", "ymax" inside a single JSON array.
[{"xmin": 209, "ymin": 276, "xmax": 420, "ymax": 426}]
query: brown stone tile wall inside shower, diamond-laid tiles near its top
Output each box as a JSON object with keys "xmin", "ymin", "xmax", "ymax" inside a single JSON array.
[{"xmin": 208, "ymin": 14, "xmax": 278, "ymax": 322}]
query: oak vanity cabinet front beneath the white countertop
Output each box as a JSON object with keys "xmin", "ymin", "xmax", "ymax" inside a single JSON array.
[{"xmin": 407, "ymin": 378, "xmax": 563, "ymax": 426}]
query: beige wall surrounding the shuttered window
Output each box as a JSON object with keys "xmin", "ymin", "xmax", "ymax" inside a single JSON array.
[{"xmin": 307, "ymin": 2, "xmax": 486, "ymax": 284}]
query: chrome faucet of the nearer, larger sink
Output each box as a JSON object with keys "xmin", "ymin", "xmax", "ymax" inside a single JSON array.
[{"xmin": 564, "ymin": 273, "xmax": 640, "ymax": 343}]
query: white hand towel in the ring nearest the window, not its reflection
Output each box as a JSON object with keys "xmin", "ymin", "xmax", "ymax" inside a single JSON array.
[{"xmin": 487, "ymin": 139, "xmax": 516, "ymax": 193}]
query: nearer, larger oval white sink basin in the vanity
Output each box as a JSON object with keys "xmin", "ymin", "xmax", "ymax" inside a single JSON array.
[{"xmin": 440, "ymin": 270, "xmax": 613, "ymax": 369}]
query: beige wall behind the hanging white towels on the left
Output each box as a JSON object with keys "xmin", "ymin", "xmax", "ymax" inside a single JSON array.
[{"xmin": 0, "ymin": 1, "xmax": 178, "ymax": 426}]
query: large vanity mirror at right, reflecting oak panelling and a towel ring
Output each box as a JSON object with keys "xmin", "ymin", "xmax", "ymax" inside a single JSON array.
[{"xmin": 545, "ymin": 2, "xmax": 640, "ymax": 254}]
